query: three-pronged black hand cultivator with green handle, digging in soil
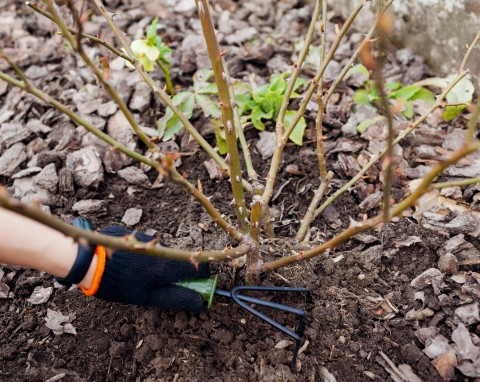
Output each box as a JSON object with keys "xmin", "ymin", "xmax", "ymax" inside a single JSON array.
[{"xmin": 176, "ymin": 275, "xmax": 312, "ymax": 371}]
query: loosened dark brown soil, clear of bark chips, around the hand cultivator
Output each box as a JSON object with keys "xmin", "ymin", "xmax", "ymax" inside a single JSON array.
[{"xmin": 0, "ymin": 150, "xmax": 438, "ymax": 381}]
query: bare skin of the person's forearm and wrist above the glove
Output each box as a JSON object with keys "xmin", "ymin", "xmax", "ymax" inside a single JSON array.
[{"xmin": 0, "ymin": 207, "xmax": 97, "ymax": 289}]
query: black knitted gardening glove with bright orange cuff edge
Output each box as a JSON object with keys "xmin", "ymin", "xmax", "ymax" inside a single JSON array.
[{"xmin": 82, "ymin": 225, "xmax": 210, "ymax": 313}]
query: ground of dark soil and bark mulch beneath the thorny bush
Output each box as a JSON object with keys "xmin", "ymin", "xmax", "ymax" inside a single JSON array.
[{"xmin": 0, "ymin": 0, "xmax": 480, "ymax": 382}]
